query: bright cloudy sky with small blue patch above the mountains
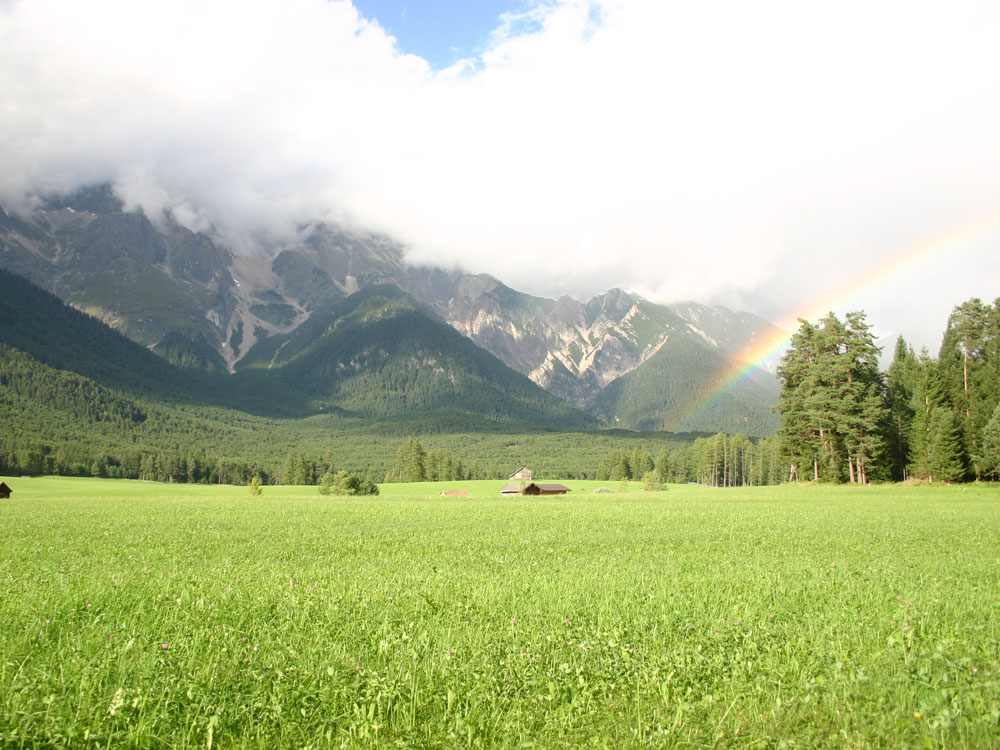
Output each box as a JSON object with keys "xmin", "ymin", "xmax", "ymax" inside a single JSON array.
[{"xmin": 0, "ymin": 0, "xmax": 1000, "ymax": 353}]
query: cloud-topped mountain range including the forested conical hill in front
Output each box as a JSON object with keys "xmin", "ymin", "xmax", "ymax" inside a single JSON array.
[{"xmin": 0, "ymin": 185, "xmax": 782, "ymax": 435}]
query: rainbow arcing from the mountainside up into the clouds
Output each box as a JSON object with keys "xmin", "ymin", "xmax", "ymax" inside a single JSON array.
[{"xmin": 677, "ymin": 210, "xmax": 1000, "ymax": 432}]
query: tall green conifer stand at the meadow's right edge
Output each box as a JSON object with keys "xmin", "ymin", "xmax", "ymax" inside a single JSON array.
[{"xmin": 777, "ymin": 299, "xmax": 1000, "ymax": 483}]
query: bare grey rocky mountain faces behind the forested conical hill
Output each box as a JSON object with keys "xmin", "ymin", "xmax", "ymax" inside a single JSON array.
[{"xmin": 0, "ymin": 186, "xmax": 778, "ymax": 434}]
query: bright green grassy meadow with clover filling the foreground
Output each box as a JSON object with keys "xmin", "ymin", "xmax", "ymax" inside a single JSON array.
[{"xmin": 0, "ymin": 477, "xmax": 1000, "ymax": 748}]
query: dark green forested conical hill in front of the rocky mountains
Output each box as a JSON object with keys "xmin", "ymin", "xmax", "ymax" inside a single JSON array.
[{"xmin": 236, "ymin": 286, "xmax": 597, "ymax": 429}]
